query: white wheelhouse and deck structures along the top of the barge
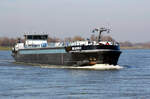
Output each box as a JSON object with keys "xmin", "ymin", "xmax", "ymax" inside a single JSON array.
[{"xmin": 14, "ymin": 34, "xmax": 117, "ymax": 50}]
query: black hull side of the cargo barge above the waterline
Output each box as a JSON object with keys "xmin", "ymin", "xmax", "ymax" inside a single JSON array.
[{"xmin": 13, "ymin": 49, "xmax": 121, "ymax": 66}]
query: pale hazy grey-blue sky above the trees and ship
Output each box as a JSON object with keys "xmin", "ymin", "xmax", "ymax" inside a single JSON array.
[{"xmin": 0, "ymin": 0, "xmax": 150, "ymax": 42}]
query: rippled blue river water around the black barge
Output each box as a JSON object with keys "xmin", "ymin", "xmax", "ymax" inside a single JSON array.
[{"xmin": 0, "ymin": 50, "xmax": 150, "ymax": 99}]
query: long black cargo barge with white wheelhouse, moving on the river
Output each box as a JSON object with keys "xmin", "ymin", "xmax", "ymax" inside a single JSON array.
[{"xmin": 12, "ymin": 27, "xmax": 121, "ymax": 66}]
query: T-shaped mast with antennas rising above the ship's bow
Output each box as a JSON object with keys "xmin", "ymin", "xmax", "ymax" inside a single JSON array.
[{"xmin": 92, "ymin": 27, "xmax": 110, "ymax": 42}]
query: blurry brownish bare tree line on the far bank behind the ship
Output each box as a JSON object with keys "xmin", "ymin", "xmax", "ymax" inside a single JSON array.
[{"xmin": 0, "ymin": 35, "xmax": 150, "ymax": 48}]
